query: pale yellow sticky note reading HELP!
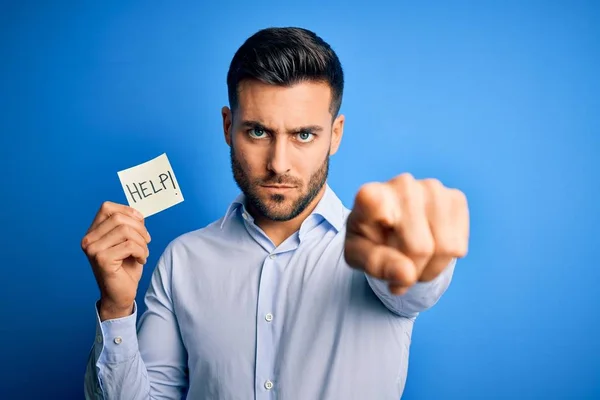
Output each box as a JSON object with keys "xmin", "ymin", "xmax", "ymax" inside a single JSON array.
[{"xmin": 117, "ymin": 153, "xmax": 183, "ymax": 217}]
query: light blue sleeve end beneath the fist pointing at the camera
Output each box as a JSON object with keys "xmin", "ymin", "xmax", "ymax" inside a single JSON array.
[{"xmin": 366, "ymin": 259, "xmax": 456, "ymax": 319}]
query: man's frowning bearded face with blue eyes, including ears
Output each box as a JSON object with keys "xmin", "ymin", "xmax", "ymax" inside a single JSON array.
[{"xmin": 223, "ymin": 81, "xmax": 344, "ymax": 221}]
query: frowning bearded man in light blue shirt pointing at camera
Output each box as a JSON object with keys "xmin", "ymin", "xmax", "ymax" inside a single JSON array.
[{"xmin": 82, "ymin": 28, "xmax": 469, "ymax": 400}]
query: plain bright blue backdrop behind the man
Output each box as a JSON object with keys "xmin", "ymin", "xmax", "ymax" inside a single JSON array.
[{"xmin": 0, "ymin": 1, "xmax": 600, "ymax": 399}]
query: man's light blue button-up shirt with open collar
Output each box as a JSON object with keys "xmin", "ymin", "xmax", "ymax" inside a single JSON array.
[{"xmin": 85, "ymin": 185, "xmax": 455, "ymax": 400}]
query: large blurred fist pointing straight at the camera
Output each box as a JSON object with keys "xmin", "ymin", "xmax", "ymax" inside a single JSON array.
[{"xmin": 344, "ymin": 174, "xmax": 469, "ymax": 295}]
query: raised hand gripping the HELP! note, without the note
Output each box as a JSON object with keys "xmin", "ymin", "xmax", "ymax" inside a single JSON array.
[{"xmin": 81, "ymin": 202, "xmax": 150, "ymax": 321}]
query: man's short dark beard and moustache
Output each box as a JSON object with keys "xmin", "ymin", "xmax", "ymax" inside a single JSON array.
[{"xmin": 229, "ymin": 145, "xmax": 329, "ymax": 221}]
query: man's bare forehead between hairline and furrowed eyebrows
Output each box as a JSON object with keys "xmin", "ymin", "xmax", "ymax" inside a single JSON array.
[{"xmin": 238, "ymin": 81, "xmax": 331, "ymax": 126}]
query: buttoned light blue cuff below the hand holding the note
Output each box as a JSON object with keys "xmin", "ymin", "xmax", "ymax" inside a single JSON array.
[{"xmin": 94, "ymin": 302, "xmax": 139, "ymax": 364}]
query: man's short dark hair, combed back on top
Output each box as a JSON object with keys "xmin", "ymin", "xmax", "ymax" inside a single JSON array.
[{"xmin": 227, "ymin": 27, "xmax": 344, "ymax": 117}]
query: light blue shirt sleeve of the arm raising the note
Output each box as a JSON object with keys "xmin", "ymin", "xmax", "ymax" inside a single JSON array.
[{"xmin": 84, "ymin": 248, "xmax": 187, "ymax": 399}]
